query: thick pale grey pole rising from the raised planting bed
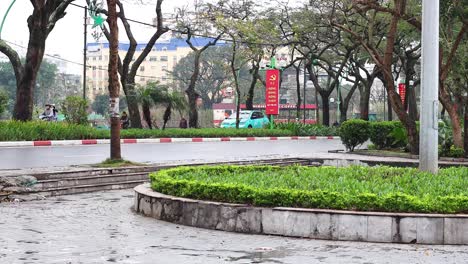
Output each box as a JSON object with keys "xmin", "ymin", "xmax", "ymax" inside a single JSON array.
[{"xmin": 419, "ymin": 0, "xmax": 439, "ymax": 173}]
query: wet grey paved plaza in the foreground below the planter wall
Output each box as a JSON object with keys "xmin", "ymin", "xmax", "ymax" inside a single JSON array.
[{"xmin": 0, "ymin": 190, "xmax": 468, "ymax": 264}]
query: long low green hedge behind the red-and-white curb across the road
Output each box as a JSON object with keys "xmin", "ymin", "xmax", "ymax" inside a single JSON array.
[{"xmin": 0, "ymin": 121, "xmax": 330, "ymax": 141}]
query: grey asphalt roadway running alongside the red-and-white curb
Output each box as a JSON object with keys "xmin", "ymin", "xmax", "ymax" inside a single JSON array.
[{"xmin": 0, "ymin": 139, "xmax": 344, "ymax": 169}]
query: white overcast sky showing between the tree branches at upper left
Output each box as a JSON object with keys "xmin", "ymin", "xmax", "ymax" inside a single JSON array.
[{"xmin": 0, "ymin": 0, "xmax": 193, "ymax": 73}]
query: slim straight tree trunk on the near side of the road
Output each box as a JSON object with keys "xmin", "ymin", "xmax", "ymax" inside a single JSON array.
[{"xmin": 107, "ymin": 0, "xmax": 122, "ymax": 160}]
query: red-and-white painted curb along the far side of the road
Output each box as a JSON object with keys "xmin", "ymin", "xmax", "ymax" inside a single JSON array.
[{"xmin": 0, "ymin": 136, "xmax": 340, "ymax": 147}]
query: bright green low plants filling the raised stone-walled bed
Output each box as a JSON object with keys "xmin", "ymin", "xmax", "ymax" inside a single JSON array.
[{"xmin": 150, "ymin": 166, "xmax": 468, "ymax": 213}]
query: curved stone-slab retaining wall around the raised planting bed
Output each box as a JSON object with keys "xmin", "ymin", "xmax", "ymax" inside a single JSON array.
[{"xmin": 134, "ymin": 184, "xmax": 468, "ymax": 245}]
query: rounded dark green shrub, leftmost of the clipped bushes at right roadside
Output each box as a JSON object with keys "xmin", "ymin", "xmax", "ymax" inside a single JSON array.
[{"xmin": 338, "ymin": 119, "xmax": 370, "ymax": 151}]
